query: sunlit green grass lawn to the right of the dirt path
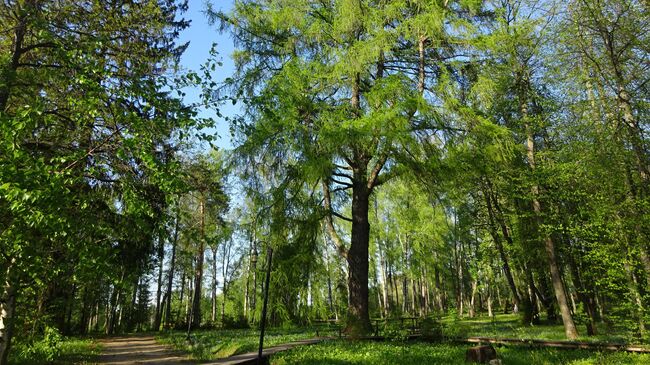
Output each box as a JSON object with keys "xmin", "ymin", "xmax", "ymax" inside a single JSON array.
[{"xmin": 157, "ymin": 314, "xmax": 650, "ymax": 365}]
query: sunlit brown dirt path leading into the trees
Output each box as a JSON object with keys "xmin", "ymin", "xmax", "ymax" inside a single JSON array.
[{"xmin": 97, "ymin": 336, "xmax": 192, "ymax": 365}]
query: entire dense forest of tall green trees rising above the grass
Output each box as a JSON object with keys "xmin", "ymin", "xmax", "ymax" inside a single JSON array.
[{"xmin": 0, "ymin": 0, "xmax": 650, "ymax": 365}]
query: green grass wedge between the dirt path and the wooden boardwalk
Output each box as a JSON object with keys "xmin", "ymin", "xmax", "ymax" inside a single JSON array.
[{"xmin": 157, "ymin": 329, "xmax": 340, "ymax": 360}]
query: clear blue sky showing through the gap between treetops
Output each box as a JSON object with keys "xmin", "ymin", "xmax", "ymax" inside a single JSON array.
[{"xmin": 179, "ymin": 0, "xmax": 239, "ymax": 149}]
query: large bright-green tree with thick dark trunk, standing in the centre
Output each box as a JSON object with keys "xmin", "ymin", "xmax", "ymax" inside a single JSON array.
[{"xmin": 210, "ymin": 0, "xmax": 480, "ymax": 334}]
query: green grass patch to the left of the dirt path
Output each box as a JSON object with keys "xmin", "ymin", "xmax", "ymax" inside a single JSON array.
[{"xmin": 9, "ymin": 337, "xmax": 101, "ymax": 365}]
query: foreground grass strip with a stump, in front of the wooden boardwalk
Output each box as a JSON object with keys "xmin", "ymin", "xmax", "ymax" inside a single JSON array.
[{"xmin": 271, "ymin": 340, "xmax": 650, "ymax": 365}]
